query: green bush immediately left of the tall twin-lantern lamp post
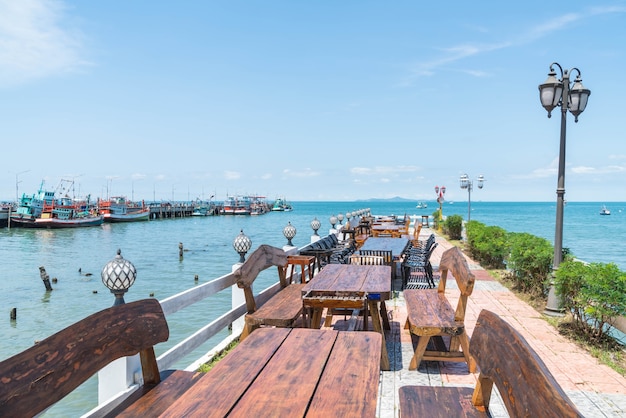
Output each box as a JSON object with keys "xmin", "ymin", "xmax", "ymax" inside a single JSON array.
[{"xmin": 507, "ymin": 233, "xmax": 554, "ymax": 296}]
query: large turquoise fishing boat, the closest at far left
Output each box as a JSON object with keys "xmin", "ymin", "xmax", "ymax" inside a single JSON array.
[{"xmin": 10, "ymin": 180, "xmax": 104, "ymax": 228}]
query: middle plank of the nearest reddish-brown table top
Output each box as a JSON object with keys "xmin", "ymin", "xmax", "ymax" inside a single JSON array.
[{"xmin": 229, "ymin": 328, "xmax": 338, "ymax": 418}]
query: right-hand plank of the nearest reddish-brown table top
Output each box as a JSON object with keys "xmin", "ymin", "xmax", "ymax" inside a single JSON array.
[{"xmin": 306, "ymin": 332, "xmax": 382, "ymax": 418}]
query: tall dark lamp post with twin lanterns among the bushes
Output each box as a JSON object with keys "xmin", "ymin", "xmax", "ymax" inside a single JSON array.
[{"xmin": 539, "ymin": 62, "xmax": 591, "ymax": 313}]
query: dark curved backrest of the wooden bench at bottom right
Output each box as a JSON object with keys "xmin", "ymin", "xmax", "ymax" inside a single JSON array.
[{"xmin": 470, "ymin": 309, "xmax": 582, "ymax": 417}]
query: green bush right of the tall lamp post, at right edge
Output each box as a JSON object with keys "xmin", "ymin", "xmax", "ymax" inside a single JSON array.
[{"xmin": 555, "ymin": 261, "xmax": 626, "ymax": 340}]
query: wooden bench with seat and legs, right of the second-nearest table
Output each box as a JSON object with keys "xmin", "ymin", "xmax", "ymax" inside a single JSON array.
[{"xmin": 404, "ymin": 247, "xmax": 476, "ymax": 373}]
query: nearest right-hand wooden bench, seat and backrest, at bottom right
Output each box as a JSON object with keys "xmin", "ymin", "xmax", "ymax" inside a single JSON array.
[{"xmin": 399, "ymin": 310, "xmax": 582, "ymax": 418}]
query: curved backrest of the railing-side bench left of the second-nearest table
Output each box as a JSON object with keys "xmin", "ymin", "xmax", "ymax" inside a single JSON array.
[{"xmin": 234, "ymin": 245, "xmax": 288, "ymax": 313}]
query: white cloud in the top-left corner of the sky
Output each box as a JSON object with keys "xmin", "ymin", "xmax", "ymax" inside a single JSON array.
[{"xmin": 0, "ymin": 0, "xmax": 87, "ymax": 87}]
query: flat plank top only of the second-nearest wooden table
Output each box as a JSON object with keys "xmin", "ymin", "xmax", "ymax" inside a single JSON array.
[{"xmin": 302, "ymin": 264, "xmax": 391, "ymax": 300}]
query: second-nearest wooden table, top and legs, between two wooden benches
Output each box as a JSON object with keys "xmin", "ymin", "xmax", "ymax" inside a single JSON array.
[{"xmin": 302, "ymin": 264, "xmax": 391, "ymax": 370}]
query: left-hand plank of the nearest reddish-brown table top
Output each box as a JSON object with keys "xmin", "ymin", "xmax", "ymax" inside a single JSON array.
[{"xmin": 158, "ymin": 328, "xmax": 290, "ymax": 418}]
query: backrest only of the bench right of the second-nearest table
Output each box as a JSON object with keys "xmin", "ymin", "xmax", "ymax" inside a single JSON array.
[{"xmin": 437, "ymin": 247, "xmax": 476, "ymax": 321}]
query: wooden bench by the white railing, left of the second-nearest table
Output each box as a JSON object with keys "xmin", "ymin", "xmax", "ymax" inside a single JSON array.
[{"xmin": 235, "ymin": 245, "xmax": 305, "ymax": 340}]
